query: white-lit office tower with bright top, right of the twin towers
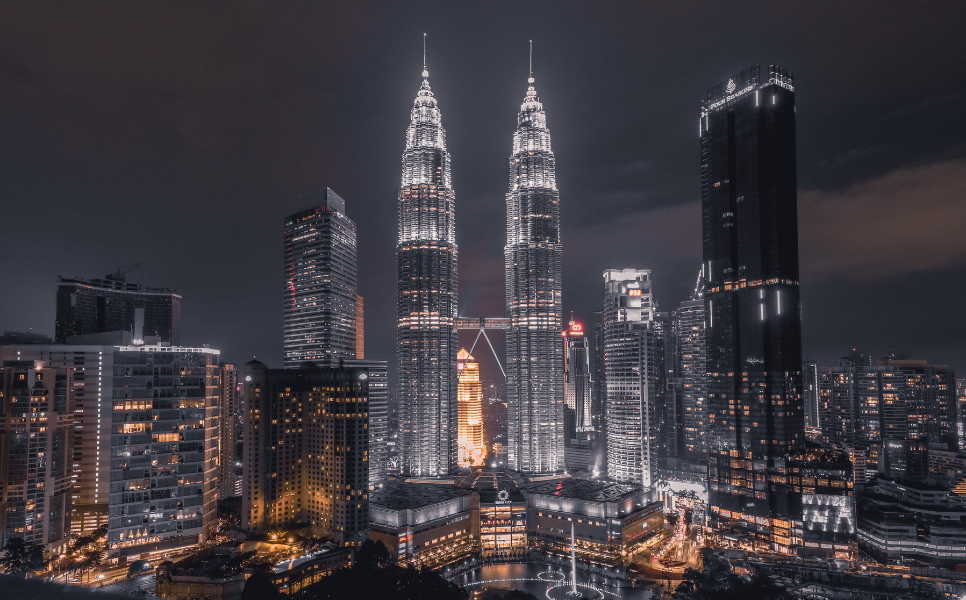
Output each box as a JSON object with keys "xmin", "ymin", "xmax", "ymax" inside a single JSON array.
[{"xmin": 604, "ymin": 269, "xmax": 667, "ymax": 488}]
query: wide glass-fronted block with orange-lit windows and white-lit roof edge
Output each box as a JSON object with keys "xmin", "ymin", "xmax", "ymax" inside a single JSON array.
[{"xmin": 107, "ymin": 344, "xmax": 219, "ymax": 559}]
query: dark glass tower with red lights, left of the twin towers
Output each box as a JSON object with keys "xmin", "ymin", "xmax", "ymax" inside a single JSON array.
[{"xmin": 284, "ymin": 187, "xmax": 358, "ymax": 368}]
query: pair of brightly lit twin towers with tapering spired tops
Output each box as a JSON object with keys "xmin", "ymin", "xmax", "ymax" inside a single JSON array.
[{"xmin": 396, "ymin": 56, "xmax": 564, "ymax": 478}]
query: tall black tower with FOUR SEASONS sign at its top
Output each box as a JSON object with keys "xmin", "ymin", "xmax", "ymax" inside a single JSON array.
[{"xmin": 699, "ymin": 65, "xmax": 805, "ymax": 552}]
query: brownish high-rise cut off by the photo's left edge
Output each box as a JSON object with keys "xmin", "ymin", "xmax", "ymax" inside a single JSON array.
[{"xmin": 0, "ymin": 360, "xmax": 74, "ymax": 550}]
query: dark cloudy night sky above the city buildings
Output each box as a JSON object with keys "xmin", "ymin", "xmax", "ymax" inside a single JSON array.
[{"xmin": 0, "ymin": 1, "xmax": 966, "ymax": 386}]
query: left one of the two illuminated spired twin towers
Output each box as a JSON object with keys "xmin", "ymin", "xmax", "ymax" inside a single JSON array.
[{"xmin": 396, "ymin": 57, "xmax": 459, "ymax": 477}]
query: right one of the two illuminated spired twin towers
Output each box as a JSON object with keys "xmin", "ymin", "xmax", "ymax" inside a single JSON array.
[{"xmin": 503, "ymin": 68, "xmax": 565, "ymax": 473}]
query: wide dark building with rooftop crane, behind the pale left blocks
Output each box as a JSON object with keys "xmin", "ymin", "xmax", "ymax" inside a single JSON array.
[{"xmin": 54, "ymin": 274, "xmax": 181, "ymax": 345}]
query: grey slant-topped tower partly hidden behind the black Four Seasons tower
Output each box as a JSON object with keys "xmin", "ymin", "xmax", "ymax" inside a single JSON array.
[{"xmin": 668, "ymin": 267, "xmax": 708, "ymax": 460}]
